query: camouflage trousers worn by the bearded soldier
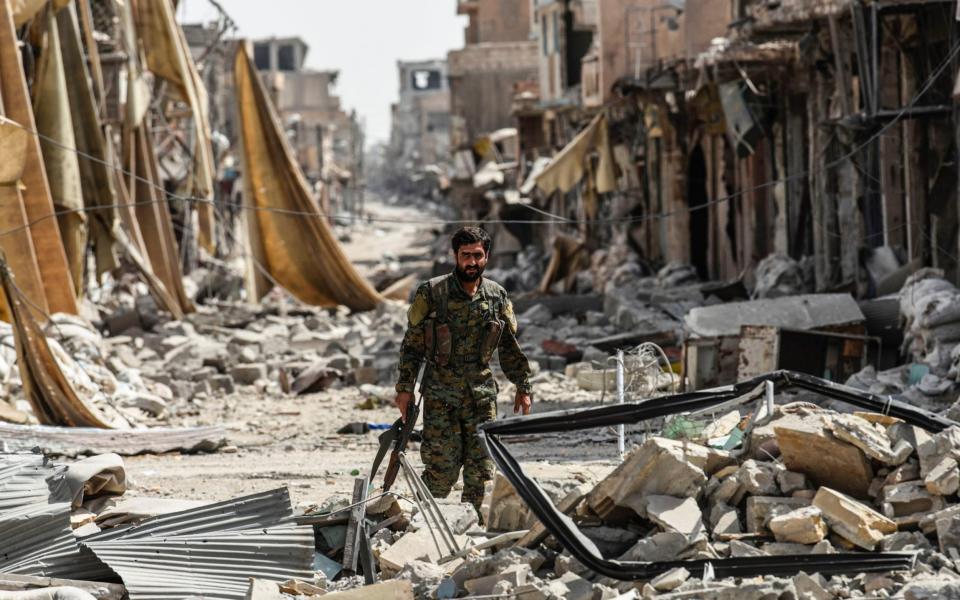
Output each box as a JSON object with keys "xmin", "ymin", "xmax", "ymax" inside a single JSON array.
[{"xmin": 420, "ymin": 394, "xmax": 497, "ymax": 514}]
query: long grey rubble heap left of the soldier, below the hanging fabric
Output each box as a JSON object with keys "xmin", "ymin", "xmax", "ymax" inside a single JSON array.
[{"xmin": 0, "ymin": 296, "xmax": 406, "ymax": 427}]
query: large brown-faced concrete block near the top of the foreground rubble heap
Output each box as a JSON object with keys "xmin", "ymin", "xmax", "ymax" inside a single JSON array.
[{"xmin": 774, "ymin": 420, "xmax": 873, "ymax": 498}]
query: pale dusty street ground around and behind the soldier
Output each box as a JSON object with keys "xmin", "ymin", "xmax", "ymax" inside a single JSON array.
[{"xmin": 127, "ymin": 204, "xmax": 616, "ymax": 508}]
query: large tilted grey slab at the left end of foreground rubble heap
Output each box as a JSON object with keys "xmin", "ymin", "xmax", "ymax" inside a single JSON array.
[{"xmin": 587, "ymin": 438, "xmax": 734, "ymax": 518}]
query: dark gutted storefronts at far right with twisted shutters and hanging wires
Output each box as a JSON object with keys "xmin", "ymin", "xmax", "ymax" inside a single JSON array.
[{"xmin": 621, "ymin": 2, "xmax": 957, "ymax": 294}]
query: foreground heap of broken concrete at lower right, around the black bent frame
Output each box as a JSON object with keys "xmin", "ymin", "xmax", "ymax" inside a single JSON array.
[{"xmin": 288, "ymin": 394, "xmax": 960, "ymax": 599}]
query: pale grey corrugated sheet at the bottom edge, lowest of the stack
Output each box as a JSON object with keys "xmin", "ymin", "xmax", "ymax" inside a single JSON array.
[{"xmin": 84, "ymin": 525, "xmax": 314, "ymax": 600}]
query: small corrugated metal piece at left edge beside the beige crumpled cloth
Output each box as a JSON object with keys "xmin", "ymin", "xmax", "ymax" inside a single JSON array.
[{"xmin": 0, "ymin": 454, "xmax": 70, "ymax": 512}]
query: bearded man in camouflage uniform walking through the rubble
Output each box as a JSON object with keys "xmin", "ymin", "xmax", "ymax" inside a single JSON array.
[{"xmin": 396, "ymin": 227, "xmax": 531, "ymax": 514}]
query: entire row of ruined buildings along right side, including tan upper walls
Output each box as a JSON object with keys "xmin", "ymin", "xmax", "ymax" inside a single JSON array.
[{"xmin": 448, "ymin": 0, "xmax": 958, "ymax": 304}]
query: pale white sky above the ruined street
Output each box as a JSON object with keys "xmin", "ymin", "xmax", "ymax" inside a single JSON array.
[{"xmin": 177, "ymin": 0, "xmax": 466, "ymax": 143}]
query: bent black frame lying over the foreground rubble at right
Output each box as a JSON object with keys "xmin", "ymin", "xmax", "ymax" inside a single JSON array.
[{"xmin": 480, "ymin": 371, "xmax": 944, "ymax": 580}]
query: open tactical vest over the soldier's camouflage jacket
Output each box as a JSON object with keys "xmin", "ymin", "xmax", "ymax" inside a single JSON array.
[{"xmin": 423, "ymin": 275, "xmax": 504, "ymax": 367}]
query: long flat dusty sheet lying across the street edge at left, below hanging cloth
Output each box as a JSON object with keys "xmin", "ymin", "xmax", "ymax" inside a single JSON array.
[{"xmin": 0, "ymin": 423, "xmax": 227, "ymax": 456}]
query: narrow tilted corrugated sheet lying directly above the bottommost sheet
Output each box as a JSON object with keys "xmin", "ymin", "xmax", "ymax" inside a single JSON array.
[{"xmin": 84, "ymin": 488, "xmax": 293, "ymax": 542}]
